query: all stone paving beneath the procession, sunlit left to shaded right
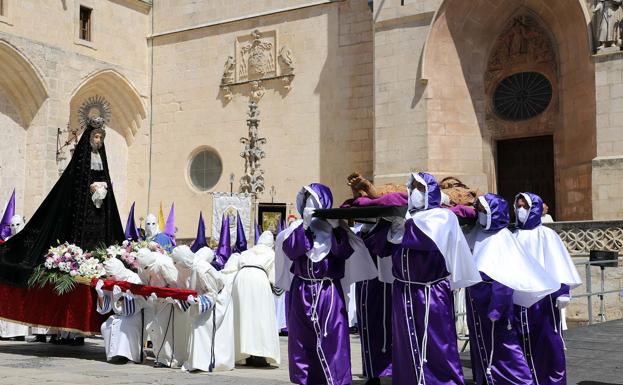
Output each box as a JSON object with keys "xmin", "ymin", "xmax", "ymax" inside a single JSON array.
[{"xmin": 0, "ymin": 320, "xmax": 623, "ymax": 385}]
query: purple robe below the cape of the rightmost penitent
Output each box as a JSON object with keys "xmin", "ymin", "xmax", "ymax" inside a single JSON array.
[{"xmin": 515, "ymin": 284, "xmax": 569, "ymax": 385}]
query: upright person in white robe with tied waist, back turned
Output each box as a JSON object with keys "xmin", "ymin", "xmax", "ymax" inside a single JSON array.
[{"xmin": 228, "ymin": 231, "xmax": 281, "ymax": 366}]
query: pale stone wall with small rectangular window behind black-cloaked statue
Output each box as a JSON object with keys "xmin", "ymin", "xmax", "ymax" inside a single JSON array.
[{"xmin": 0, "ymin": 0, "xmax": 149, "ymax": 217}]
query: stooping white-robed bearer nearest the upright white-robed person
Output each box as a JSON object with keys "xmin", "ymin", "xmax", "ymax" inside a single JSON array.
[{"xmin": 171, "ymin": 246, "xmax": 235, "ymax": 372}]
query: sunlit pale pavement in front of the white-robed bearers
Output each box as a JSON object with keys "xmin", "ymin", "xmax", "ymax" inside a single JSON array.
[{"xmin": 0, "ymin": 337, "xmax": 390, "ymax": 385}]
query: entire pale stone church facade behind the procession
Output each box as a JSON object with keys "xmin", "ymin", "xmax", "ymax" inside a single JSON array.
[{"xmin": 0, "ymin": 0, "xmax": 623, "ymax": 237}]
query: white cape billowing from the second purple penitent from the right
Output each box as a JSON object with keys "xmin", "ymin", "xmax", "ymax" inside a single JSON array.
[{"xmin": 468, "ymin": 224, "xmax": 560, "ymax": 307}]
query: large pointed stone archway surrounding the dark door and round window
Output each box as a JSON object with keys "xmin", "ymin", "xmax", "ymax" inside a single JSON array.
[{"xmin": 422, "ymin": 0, "xmax": 596, "ymax": 220}]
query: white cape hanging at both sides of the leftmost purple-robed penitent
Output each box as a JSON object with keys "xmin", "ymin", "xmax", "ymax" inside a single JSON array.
[{"xmin": 275, "ymin": 219, "xmax": 378, "ymax": 297}]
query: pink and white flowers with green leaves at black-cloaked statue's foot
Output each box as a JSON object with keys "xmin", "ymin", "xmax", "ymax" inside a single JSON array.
[{"xmin": 28, "ymin": 242, "xmax": 106, "ymax": 295}]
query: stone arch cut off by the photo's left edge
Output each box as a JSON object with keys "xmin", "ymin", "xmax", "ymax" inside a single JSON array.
[{"xmin": 0, "ymin": 40, "xmax": 48, "ymax": 213}]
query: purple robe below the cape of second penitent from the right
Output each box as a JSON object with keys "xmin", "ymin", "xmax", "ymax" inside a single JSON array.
[{"xmin": 466, "ymin": 273, "xmax": 533, "ymax": 385}]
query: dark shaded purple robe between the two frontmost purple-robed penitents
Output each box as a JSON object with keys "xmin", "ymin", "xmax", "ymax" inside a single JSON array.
[{"xmin": 355, "ymin": 220, "xmax": 392, "ymax": 378}]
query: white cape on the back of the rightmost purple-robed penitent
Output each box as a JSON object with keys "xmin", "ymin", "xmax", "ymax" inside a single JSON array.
[{"xmin": 515, "ymin": 226, "xmax": 582, "ymax": 289}]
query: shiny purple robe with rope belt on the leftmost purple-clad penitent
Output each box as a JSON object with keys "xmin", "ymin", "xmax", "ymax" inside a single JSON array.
[{"xmin": 283, "ymin": 225, "xmax": 353, "ymax": 385}]
